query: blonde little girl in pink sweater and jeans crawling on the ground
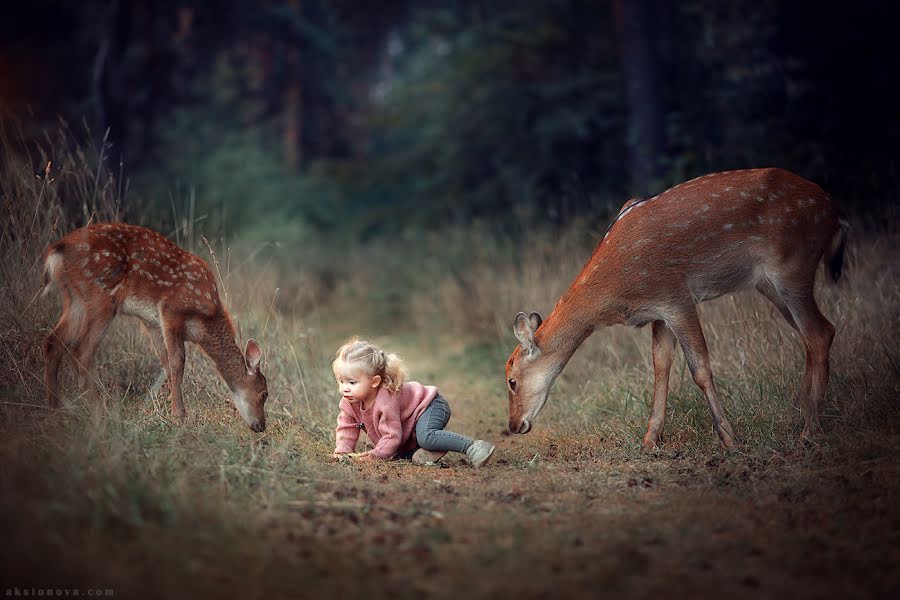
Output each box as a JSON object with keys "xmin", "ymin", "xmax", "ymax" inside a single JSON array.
[{"xmin": 331, "ymin": 337, "xmax": 494, "ymax": 468}]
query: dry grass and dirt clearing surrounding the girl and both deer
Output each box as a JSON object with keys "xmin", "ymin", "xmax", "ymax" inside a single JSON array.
[{"xmin": 0, "ymin": 129, "xmax": 900, "ymax": 598}]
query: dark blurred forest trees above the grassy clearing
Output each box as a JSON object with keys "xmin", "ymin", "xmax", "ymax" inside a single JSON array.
[{"xmin": 0, "ymin": 0, "xmax": 900, "ymax": 241}]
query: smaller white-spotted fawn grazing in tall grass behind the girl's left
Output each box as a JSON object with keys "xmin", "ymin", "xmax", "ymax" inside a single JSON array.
[{"xmin": 44, "ymin": 223, "xmax": 268, "ymax": 431}]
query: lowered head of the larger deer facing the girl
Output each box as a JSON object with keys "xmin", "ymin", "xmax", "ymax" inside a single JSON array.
[{"xmin": 506, "ymin": 313, "xmax": 557, "ymax": 433}]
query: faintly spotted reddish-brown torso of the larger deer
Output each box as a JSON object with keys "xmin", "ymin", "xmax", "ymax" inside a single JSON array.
[{"xmin": 591, "ymin": 169, "xmax": 838, "ymax": 300}]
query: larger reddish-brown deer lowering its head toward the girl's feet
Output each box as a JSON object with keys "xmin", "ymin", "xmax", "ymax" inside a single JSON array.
[{"xmin": 506, "ymin": 169, "xmax": 848, "ymax": 449}]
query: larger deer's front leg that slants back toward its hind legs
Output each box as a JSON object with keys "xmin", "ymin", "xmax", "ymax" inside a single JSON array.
[{"xmin": 667, "ymin": 306, "xmax": 735, "ymax": 448}]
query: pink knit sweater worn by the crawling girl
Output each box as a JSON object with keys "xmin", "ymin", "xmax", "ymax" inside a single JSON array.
[{"xmin": 334, "ymin": 381, "xmax": 438, "ymax": 460}]
